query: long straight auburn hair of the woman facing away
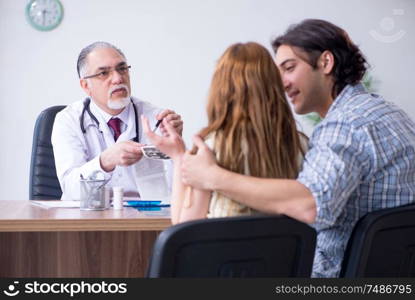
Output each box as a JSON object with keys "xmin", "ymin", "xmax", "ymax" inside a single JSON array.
[{"xmin": 198, "ymin": 42, "xmax": 304, "ymax": 178}]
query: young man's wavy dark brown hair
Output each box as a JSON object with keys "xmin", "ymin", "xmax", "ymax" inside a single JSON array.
[{"xmin": 272, "ymin": 19, "xmax": 367, "ymax": 97}]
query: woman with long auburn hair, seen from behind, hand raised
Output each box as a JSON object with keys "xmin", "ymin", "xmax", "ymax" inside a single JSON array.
[{"xmin": 142, "ymin": 42, "xmax": 304, "ymax": 223}]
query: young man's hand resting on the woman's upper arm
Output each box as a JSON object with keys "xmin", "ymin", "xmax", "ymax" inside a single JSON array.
[{"xmin": 181, "ymin": 135, "xmax": 220, "ymax": 190}]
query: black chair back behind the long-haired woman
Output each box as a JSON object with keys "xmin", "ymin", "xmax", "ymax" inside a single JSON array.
[{"xmin": 147, "ymin": 216, "xmax": 316, "ymax": 278}]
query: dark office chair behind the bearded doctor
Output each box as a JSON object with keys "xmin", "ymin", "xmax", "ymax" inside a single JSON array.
[{"xmin": 29, "ymin": 105, "xmax": 65, "ymax": 200}]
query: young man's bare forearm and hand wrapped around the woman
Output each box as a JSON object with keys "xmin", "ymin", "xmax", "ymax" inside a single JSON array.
[{"xmin": 181, "ymin": 136, "xmax": 316, "ymax": 223}]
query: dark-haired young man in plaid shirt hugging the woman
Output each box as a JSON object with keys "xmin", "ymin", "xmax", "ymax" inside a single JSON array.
[{"xmin": 182, "ymin": 20, "xmax": 415, "ymax": 277}]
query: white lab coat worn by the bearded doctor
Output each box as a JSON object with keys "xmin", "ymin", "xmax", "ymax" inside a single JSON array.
[{"xmin": 51, "ymin": 98, "xmax": 172, "ymax": 200}]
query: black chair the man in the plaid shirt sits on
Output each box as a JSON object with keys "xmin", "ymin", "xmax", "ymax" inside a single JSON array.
[{"xmin": 340, "ymin": 204, "xmax": 415, "ymax": 278}]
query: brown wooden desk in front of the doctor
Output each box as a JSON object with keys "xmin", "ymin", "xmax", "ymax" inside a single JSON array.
[{"xmin": 0, "ymin": 201, "xmax": 171, "ymax": 277}]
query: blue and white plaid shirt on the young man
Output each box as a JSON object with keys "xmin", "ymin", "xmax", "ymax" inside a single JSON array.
[{"xmin": 298, "ymin": 84, "xmax": 415, "ymax": 277}]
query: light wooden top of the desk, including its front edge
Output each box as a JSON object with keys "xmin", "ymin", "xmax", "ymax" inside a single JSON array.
[{"xmin": 0, "ymin": 200, "xmax": 171, "ymax": 232}]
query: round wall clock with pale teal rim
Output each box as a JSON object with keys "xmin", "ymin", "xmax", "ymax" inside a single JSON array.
[{"xmin": 26, "ymin": 0, "xmax": 63, "ymax": 31}]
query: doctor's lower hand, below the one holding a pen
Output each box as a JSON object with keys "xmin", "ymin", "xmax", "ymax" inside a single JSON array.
[{"xmin": 99, "ymin": 141, "xmax": 144, "ymax": 172}]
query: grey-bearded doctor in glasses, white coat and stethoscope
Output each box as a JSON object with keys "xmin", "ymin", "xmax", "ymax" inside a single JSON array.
[{"xmin": 52, "ymin": 42, "xmax": 183, "ymax": 200}]
